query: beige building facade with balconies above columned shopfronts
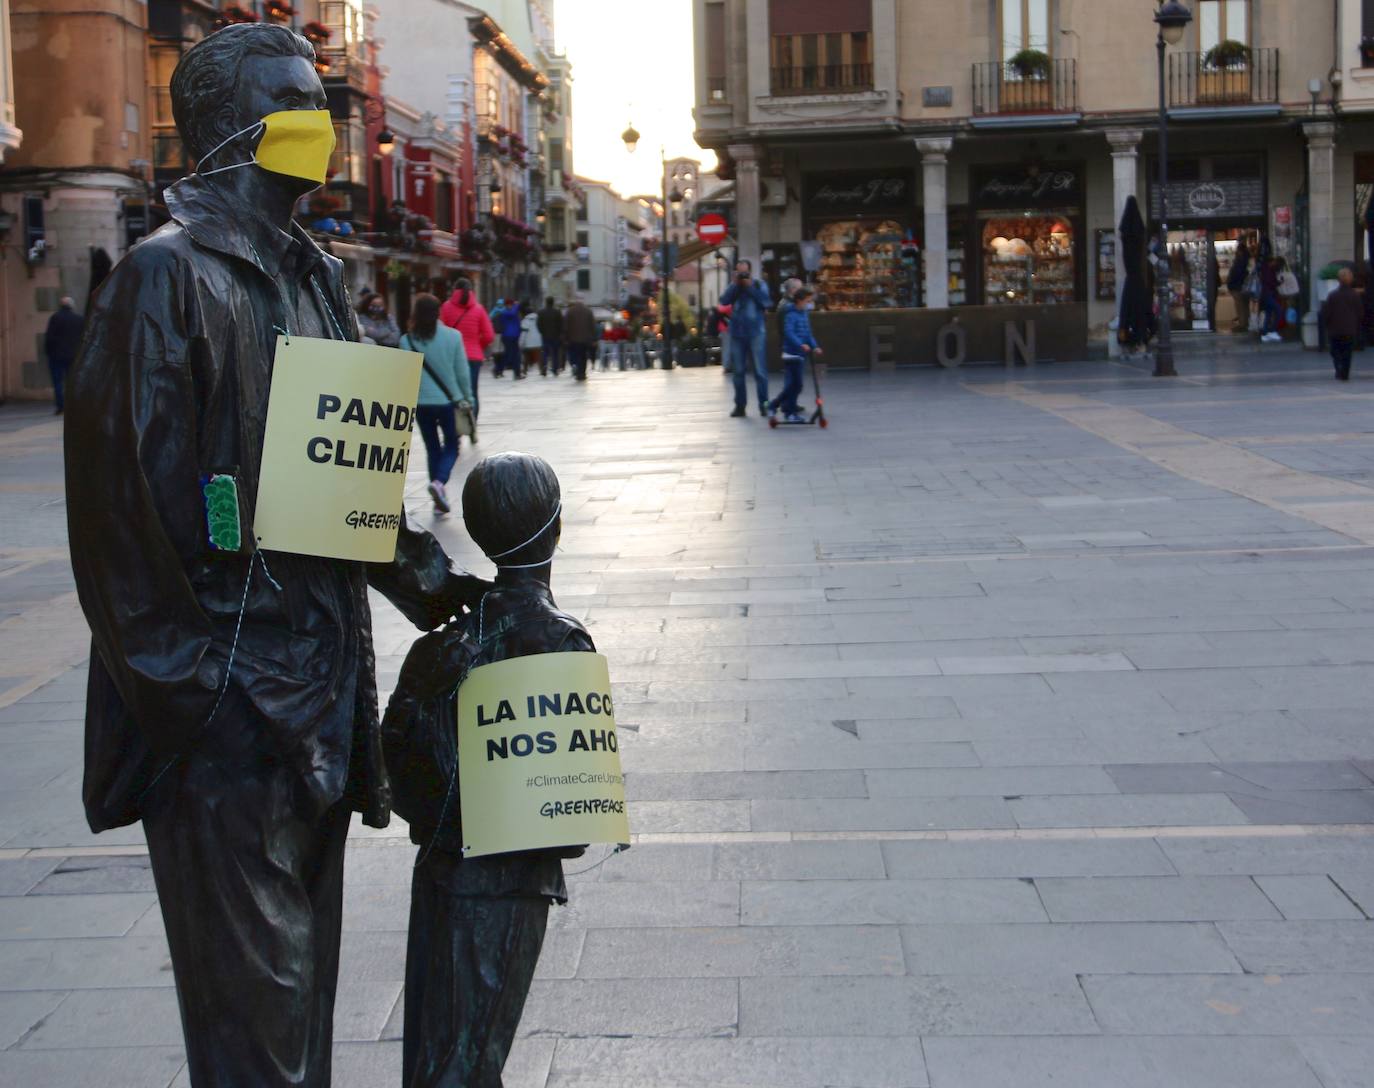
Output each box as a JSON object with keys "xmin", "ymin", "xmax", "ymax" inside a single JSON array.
[{"xmin": 694, "ymin": 0, "xmax": 1357, "ymax": 362}]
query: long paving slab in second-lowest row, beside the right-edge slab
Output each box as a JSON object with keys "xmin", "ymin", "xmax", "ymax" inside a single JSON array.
[{"xmin": 739, "ymin": 975, "xmax": 1098, "ymax": 1037}]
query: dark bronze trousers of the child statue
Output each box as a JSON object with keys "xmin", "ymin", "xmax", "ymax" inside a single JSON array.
[{"xmin": 401, "ymin": 853, "xmax": 548, "ymax": 1088}]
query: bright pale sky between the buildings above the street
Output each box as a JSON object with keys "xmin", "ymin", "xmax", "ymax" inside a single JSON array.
[{"xmin": 554, "ymin": 0, "xmax": 714, "ymax": 195}]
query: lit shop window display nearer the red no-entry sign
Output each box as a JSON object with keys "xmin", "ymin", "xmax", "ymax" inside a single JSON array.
[{"xmin": 816, "ymin": 220, "xmax": 918, "ymax": 310}]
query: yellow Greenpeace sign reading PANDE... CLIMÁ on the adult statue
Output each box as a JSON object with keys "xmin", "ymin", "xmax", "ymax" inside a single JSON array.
[{"xmin": 253, "ymin": 337, "xmax": 423, "ymax": 563}]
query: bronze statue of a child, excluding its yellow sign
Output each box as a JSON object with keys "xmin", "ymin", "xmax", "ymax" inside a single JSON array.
[{"xmin": 382, "ymin": 453, "xmax": 595, "ymax": 1088}]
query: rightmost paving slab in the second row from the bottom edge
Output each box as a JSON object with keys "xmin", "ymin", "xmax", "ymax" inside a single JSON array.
[{"xmin": 1083, "ymin": 974, "xmax": 1374, "ymax": 1036}]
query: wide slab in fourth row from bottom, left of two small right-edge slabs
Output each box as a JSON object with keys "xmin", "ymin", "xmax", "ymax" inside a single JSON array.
[{"xmin": 1035, "ymin": 876, "xmax": 1279, "ymax": 922}]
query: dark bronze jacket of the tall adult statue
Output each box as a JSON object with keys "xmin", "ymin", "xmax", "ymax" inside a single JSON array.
[{"xmin": 66, "ymin": 177, "xmax": 466, "ymax": 831}]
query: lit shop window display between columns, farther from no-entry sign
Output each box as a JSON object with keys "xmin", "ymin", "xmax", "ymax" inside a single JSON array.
[{"xmin": 982, "ymin": 216, "xmax": 1076, "ymax": 306}]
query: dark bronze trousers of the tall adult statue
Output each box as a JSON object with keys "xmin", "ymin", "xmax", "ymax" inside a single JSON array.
[{"xmin": 143, "ymin": 756, "xmax": 349, "ymax": 1088}]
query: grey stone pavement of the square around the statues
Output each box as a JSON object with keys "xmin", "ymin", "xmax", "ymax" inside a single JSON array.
[{"xmin": 0, "ymin": 353, "xmax": 1374, "ymax": 1088}]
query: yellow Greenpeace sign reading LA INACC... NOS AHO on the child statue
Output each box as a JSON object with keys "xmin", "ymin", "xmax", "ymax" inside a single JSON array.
[{"xmin": 458, "ymin": 654, "xmax": 629, "ymax": 857}]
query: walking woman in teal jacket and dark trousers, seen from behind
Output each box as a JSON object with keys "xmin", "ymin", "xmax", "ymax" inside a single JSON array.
[{"xmin": 401, "ymin": 294, "xmax": 473, "ymax": 514}]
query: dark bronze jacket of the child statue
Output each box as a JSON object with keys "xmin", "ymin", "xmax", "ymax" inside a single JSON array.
[{"xmin": 382, "ymin": 573, "xmax": 596, "ymax": 901}]
